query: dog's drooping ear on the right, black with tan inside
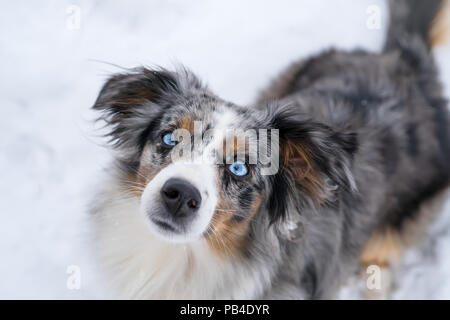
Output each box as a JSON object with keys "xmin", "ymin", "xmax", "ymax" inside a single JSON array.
[{"xmin": 268, "ymin": 107, "xmax": 357, "ymax": 221}]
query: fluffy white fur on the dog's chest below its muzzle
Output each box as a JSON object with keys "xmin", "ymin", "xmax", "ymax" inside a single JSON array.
[{"xmin": 93, "ymin": 182, "xmax": 268, "ymax": 299}]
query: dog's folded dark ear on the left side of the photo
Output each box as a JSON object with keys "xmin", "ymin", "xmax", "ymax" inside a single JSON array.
[{"xmin": 93, "ymin": 67, "xmax": 202, "ymax": 148}]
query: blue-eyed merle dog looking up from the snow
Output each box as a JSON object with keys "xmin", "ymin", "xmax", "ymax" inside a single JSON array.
[{"xmin": 90, "ymin": 0, "xmax": 450, "ymax": 299}]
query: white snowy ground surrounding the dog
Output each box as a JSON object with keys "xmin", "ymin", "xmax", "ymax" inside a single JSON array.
[{"xmin": 0, "ymin": 0, "xmax": 450, "ymax": 299}]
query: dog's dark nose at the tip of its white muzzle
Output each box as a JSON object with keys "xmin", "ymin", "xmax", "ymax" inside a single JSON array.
[{"xmin": 161, "ymin": 178, "xmax": 202, "ymax": 217}]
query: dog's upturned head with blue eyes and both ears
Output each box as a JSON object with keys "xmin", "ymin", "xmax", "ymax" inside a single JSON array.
[{"xmin": 94, "ymin": 68, "xmax": 356, "ymax": 255}]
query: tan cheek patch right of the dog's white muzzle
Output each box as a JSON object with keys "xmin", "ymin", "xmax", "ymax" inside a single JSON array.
[{"xmin": 206, "ymin": 188, "xmax": 262, "ymax": 258}]
